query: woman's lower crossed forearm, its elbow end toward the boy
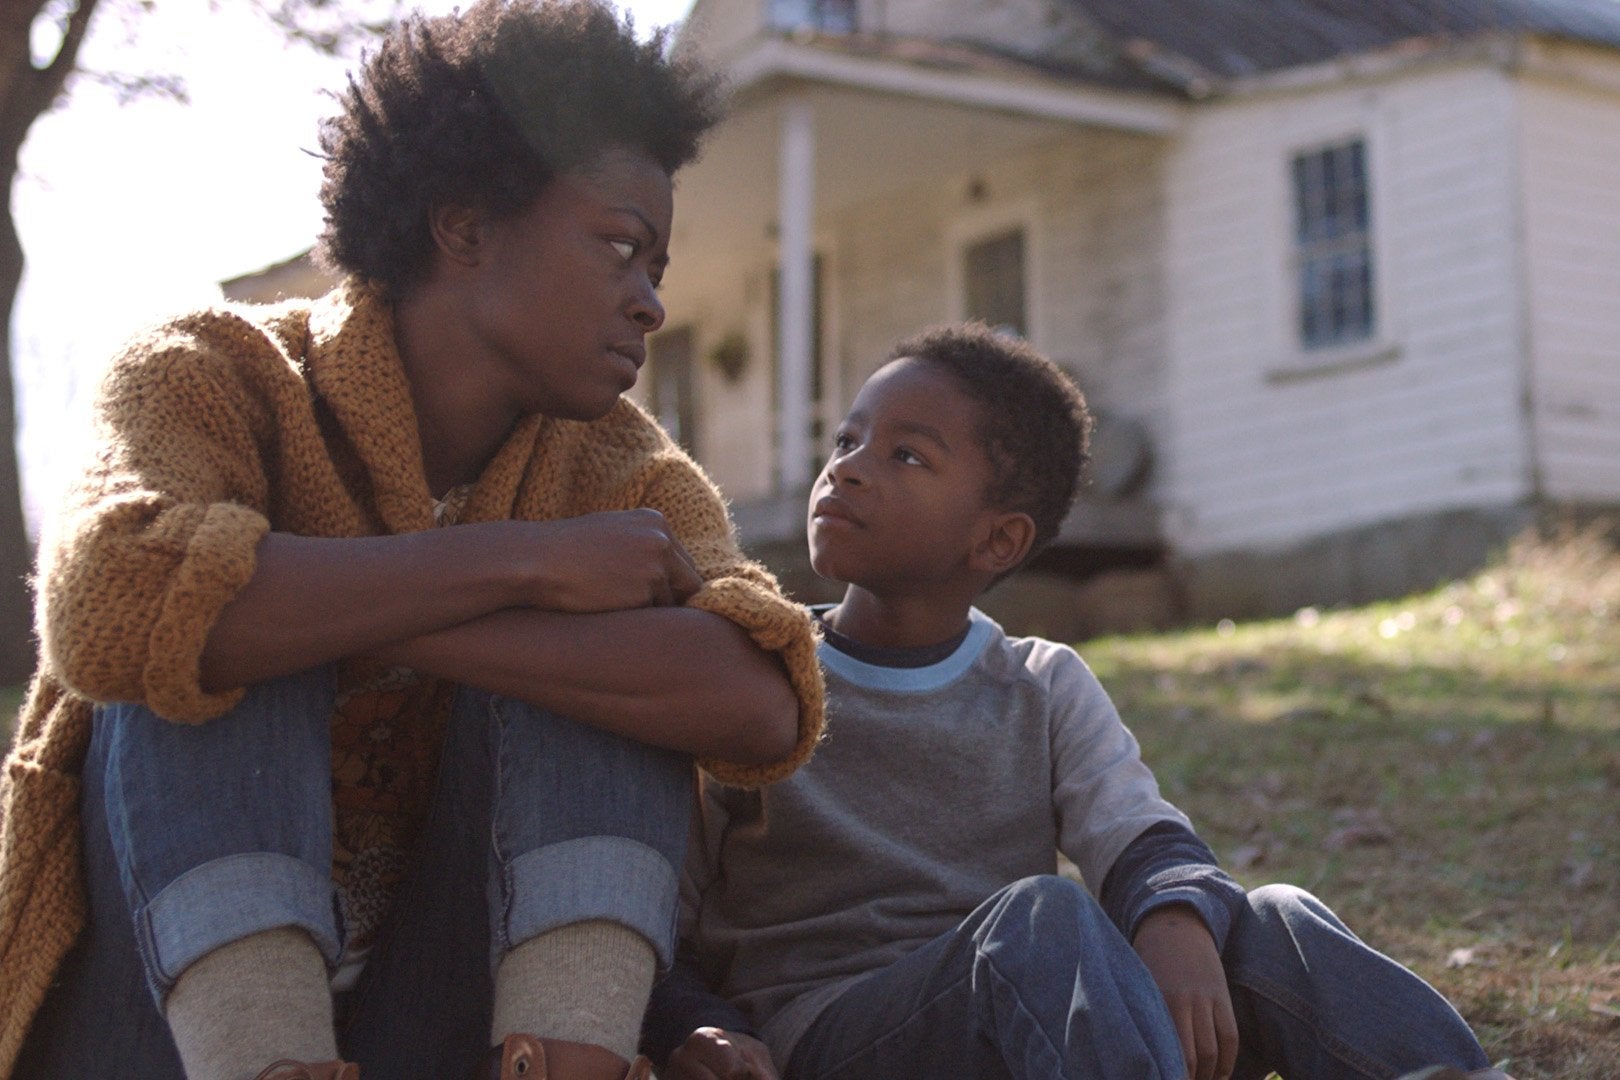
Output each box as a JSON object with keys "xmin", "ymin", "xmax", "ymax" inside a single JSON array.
[{"xmin": 379, "ymin": 607, "xmax": 799, "ymax": 764}]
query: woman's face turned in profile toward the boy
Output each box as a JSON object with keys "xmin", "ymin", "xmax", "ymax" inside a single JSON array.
[{"xmin": 470, "ymin": 147, "xmax": 674, "ymax": 419}]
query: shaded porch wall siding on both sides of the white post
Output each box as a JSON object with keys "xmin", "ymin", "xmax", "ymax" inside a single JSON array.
[{"xmin": 686, "ymin": 120, "xmax": 1168, "ymax": 500}]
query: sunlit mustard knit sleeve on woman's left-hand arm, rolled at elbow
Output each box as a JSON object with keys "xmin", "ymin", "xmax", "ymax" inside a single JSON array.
[{"xmin": 39, "ymin": 319, "xmax": 274, "ymax": 722}]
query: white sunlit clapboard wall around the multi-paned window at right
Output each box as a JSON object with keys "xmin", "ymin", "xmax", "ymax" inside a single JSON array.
[{"xmin": 1163, "ymin": 65, "xmax": 1529, "ymax": 559}]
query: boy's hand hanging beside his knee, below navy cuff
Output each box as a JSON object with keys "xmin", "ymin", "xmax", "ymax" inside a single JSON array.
[{"xmin": 1131, "ymin": 905, "xmax": 1238, "ymax": 1080}]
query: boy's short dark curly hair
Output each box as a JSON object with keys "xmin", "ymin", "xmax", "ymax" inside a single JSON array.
[{"xmin": 889, "ymin": 322, "xmax": 1092, "ymax": 562}]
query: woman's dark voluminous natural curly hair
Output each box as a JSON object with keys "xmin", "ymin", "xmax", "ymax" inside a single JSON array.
[{"xmin": 318, "ymin": 0, "xmax": 719, "ymax": 296}]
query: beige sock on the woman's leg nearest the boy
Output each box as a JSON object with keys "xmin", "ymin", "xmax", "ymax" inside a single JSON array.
[{"xmin": 489, "ymin": 920, "xmax": 658, "ymax": 1061}]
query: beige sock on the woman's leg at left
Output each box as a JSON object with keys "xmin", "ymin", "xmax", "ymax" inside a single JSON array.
[{"xmin": 164, "ymin": 926, "xmax": 337, "ymax": 1080}]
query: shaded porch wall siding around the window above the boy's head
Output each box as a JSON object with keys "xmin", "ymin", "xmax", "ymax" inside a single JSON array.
[{"xmin": 834, "ymin": 131, "xmax": 1165, "ymax": 463}]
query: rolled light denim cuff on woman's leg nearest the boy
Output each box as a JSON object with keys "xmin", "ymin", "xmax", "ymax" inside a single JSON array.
[{"xmin": 505, "ymin": 836, "xmax": 680, "ymax": 972}]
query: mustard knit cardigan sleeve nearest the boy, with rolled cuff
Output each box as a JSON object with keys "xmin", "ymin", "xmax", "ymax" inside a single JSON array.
[{"xmin": 642, "ymin": 447, "xmax": 825, "ymax": 787}]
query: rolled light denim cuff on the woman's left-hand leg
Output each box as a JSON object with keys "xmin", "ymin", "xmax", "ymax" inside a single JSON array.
[{"xmin": 134, "ymin": 852, "xmax": 342, "ymax": 1009}]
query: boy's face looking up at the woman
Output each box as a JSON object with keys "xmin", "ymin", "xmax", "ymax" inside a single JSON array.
[{"xmin": 808, "ymin": 358, "xmax": 996, "ymax": 593}]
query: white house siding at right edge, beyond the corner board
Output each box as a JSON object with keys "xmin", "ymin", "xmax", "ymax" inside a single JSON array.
[{"xmin": 1518, "ymin": 57, "xmax": 1620, "ymax": 505}]
